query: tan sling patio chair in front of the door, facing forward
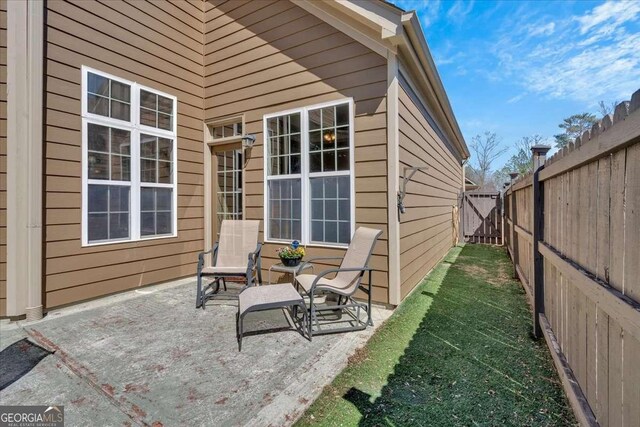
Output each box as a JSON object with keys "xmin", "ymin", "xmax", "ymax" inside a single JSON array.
[{"xmin": 196, "ymin": 220, "xmax": 262, "ymax": 310}]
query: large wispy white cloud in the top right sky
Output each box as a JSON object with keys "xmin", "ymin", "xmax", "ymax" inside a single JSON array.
[{"xmin": 490, "ymin": 2, "xmax": 640, "ymax": 103}]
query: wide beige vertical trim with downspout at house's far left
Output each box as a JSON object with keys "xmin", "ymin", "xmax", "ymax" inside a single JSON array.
[{"xmin": 6, "ymin": 0, "xmax": 44, "ymax": 321}]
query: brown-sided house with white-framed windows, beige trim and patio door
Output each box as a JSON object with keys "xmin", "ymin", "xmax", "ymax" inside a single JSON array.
[{"xmin": 0, "ymin": 0, "xmax": 469, "ymax": 318}]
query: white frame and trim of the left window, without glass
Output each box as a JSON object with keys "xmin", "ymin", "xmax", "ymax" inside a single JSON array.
[{"xmin": 81, "ymin": 65, "xmax": 178, "ymax": 247}]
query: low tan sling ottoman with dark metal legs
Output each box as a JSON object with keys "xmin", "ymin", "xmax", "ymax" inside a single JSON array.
[{"xmin": 237, "ymin": 283, "xmax": 311, "ymax": 351}]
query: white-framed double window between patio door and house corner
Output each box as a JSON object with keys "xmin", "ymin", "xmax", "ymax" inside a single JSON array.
[{"xmin": 264, "ymin": 100, "xmax": 355, "ymax": 246}]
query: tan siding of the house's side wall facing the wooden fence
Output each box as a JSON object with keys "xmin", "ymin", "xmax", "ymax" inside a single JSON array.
[{"xmin": 399, "ymin": 85, "xmax": 462, "ymax": 298}]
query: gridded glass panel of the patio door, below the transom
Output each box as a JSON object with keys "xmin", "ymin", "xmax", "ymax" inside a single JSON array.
[{"xmin": 216, "ymin": 150, "xmax": 243, "ymax": 230}]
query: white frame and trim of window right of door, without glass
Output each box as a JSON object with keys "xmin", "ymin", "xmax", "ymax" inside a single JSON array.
[{"xmin": 262, "ymin": 98, "xmax": 356, "ymax": 248}]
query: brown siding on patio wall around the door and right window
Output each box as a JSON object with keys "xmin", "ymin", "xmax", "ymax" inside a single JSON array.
[{"xmin": 204, "ymin": 0, "xmax": 388, "ymax": 302}]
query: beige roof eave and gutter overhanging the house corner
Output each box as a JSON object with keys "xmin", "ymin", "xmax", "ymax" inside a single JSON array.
[{"xmin": 293, "ymin": 0, "xmax": 470, "ymax": 159}]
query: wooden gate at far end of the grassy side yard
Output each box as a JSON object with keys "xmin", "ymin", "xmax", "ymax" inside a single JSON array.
[{"xmin": 462, "ymin": 191, "xmax": 503, "ymax": 245}]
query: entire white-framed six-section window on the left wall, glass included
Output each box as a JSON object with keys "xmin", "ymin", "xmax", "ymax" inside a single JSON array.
[{"xmin": 82, "ymin": 66, "xmax": 177, "ymax": 245}]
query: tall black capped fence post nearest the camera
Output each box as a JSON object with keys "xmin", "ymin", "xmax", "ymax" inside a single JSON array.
[{"xmin": 531, "ymin": 145, "xmax": 551, "ymax": 338}]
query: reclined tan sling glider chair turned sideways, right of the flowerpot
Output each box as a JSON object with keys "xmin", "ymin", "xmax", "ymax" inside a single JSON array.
[{"xmin": 296, "ymin": 227, "xmax": 382, "ymax": 336}]
